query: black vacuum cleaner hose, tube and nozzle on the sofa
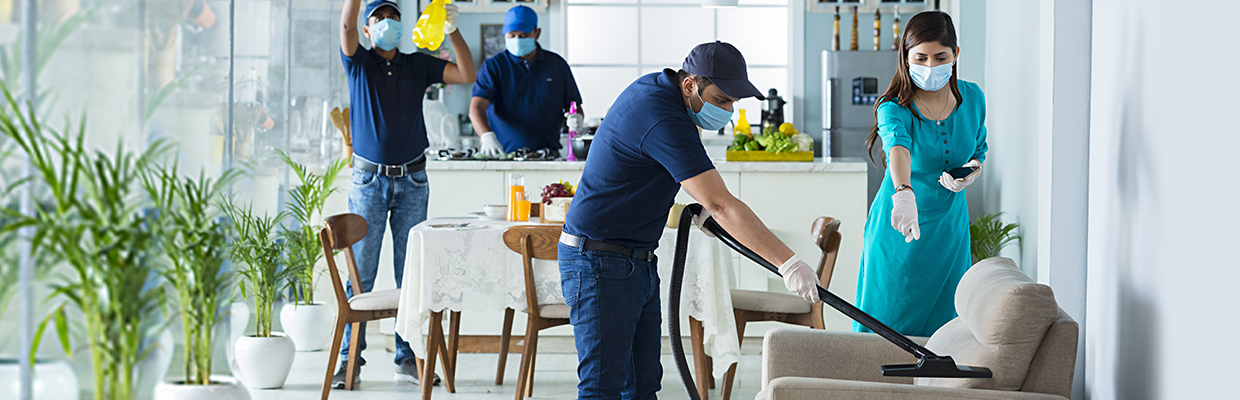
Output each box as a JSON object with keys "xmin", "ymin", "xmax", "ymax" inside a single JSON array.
[{"xmin": 667, "ymin": 203, "xmax": 992, "ymax": 400}]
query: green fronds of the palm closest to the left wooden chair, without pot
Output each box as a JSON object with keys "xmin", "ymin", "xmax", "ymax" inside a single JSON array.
[{"xmin": 280, "ymin": 151, "xmax": 348, "ymax": 305}]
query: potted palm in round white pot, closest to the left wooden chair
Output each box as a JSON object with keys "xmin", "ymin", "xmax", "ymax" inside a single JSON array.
[{"xmin": 280, "ymin": 152, "xmax": 348, "ymax": 352}]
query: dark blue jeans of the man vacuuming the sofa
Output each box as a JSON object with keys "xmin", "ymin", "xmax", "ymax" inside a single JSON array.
[{"xmin": 559, "ymin": 244, "xmax": 663, "ymax": 399}]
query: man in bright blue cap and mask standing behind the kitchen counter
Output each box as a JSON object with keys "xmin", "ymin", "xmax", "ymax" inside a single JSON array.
[{"xmin": 469, "ymin": 5, "xmax": 582, "ymax": 156}]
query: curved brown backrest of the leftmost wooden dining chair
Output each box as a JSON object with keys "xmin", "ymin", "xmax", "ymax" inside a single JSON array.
[{"xmin": 319, "ymin": 214, "xmax": 368, "ymax": 310}]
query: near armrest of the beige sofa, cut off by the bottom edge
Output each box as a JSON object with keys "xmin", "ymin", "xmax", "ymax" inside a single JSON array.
[{"xmin": 758, "ymin": 376, "xmax": 1068, "ymax": 400}]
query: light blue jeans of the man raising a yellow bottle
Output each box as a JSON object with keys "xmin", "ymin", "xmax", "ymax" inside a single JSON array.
[{"xmin": 340, "ymin": 168, "xmax": 430, "ymax": 365}]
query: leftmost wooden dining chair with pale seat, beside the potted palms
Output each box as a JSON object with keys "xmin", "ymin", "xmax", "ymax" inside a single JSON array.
[{"xmin": 319, "ymin": 214, "xmax": 438, "ymax": 400}]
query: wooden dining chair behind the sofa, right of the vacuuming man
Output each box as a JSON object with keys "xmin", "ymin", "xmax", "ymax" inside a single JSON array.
[{"xmin": 719, "ymin": 217, "xmax": 841, "ymax": 400}]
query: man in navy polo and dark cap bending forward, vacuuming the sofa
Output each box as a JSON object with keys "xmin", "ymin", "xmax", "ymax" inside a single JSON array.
[{"xmin": 559, "ymin": 41, "xmax": 818, "ymax": 399}]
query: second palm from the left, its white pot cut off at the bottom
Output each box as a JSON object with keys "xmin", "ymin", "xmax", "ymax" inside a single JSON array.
[{"xmin": 143, "ymin": 166, "xmax": 249, "ymax": 400}]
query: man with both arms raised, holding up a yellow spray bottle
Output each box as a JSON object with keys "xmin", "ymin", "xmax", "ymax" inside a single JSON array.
[{"xmin": 332, "ymin": 0, "xmax": 475, "ymax": 388}]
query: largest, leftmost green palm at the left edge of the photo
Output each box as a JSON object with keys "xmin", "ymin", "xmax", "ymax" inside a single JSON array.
[{"xmin": 0, "ymin": 89, "xmax": 166, "ymax": 400}]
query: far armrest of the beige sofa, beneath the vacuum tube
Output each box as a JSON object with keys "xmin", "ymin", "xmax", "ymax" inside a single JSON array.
[{"xmin": 763, "ymin": 328, "xmax": 926, "ymax": 388}]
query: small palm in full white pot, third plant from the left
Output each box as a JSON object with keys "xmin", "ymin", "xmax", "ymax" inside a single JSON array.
[{"xmin": 221, "ymin": 198, "xmax": 300, "ymax": 389}]
